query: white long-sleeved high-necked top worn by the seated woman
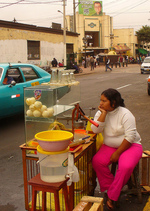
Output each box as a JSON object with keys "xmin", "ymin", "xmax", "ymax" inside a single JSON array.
[{"xmin": 91, "ymin": 107, "xmax": 141, "ymax": 148}]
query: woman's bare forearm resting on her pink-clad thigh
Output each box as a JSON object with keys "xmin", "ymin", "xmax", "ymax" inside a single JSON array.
[{"xmin": 110, "ymin": 139, "xmax": 131, "ymax": 162}]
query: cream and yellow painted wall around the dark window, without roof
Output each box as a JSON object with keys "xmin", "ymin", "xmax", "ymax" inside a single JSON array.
[{"xmin": 0, "ymin": 27, "xmax": 78, "ymax": 66}]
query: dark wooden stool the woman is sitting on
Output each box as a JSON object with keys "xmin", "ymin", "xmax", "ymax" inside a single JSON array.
[{"xmin": 111, "ymin": 162, "xmax": 142, "ymax": 203}]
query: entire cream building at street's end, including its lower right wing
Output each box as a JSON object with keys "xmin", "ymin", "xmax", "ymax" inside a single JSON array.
[{"xmin": 66, "ymin": 6, "xmax": 137, "ymax": 62}]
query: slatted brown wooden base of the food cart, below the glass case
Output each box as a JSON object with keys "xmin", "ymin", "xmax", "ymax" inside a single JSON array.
[{"xmin": 20, "ymin": 134, "xmax": 97, "ymax": 211}]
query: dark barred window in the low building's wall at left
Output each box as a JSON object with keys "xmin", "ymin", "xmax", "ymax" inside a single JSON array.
[{"xmin": 27, "ymin": 40, "xmax": 40, "ymax": 60}]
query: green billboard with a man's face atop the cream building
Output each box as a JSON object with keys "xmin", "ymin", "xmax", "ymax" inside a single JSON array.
[{"xmin": 79, "ymin": 0, "xmax": 103, "ymax": 16}]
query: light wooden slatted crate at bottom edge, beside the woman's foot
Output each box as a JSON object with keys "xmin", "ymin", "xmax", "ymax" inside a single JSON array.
[{"xmin": 73, "ymin": 196, "xmax": 103, "ymax": 211}]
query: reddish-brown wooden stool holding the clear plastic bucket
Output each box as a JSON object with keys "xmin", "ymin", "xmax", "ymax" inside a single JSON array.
[{"xmin": 28, "ymin": 174, "xmax": 70, "ymax": 211}]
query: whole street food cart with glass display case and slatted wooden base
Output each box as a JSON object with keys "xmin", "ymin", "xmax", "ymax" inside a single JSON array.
[{"xmin": 20, "ymin": 71, "xmax": 96, "ymax": 210}]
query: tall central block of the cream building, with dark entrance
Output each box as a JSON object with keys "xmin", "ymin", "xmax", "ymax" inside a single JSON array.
[{"xmin": 66, "ymin": 12, "xmax": 113, "ymax": 54}]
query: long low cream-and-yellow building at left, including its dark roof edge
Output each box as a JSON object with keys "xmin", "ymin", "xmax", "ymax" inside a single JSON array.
[{"xmin": 0, "ymin": 21, "xmax": 78, "ymax": 66}]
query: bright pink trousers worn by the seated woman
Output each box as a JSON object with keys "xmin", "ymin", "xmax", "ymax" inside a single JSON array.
[{"xmin": 92, "ymin": 144, "xmax": 143, "ymax": 201}]
